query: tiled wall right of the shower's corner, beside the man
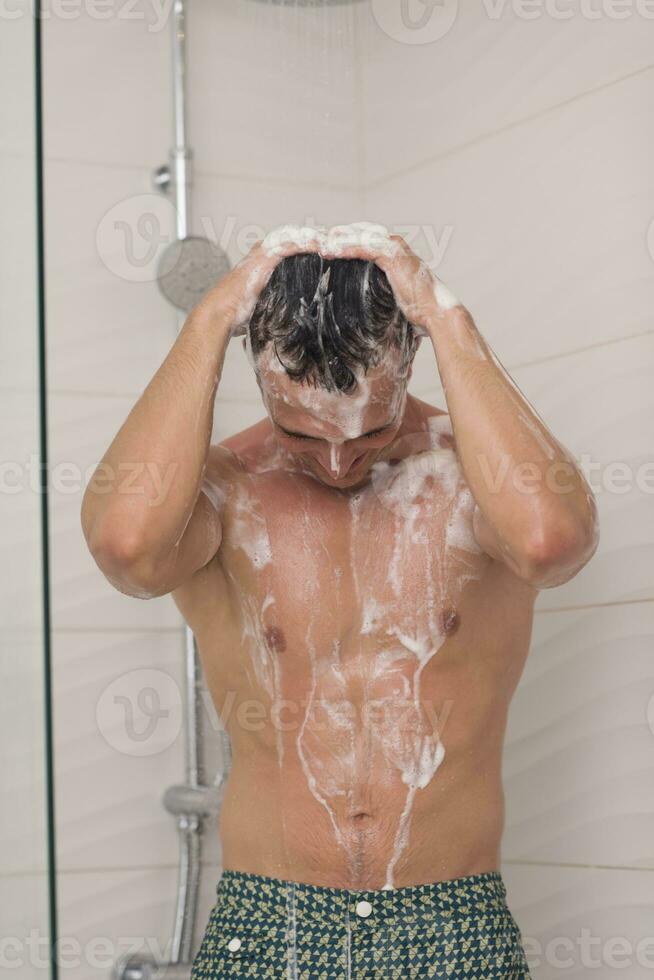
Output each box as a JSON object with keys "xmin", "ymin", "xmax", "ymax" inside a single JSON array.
[{"xmin": 359, "ymin": 0, "xmax": 654, "ymax": 980}]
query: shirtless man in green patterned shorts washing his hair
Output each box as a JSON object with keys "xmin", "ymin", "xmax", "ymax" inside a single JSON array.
[{"xmin": 83, "ymin": 224, "xmax": 597, "ymax": 980}]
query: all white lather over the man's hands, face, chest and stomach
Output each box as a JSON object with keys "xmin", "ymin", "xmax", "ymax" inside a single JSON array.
[{"xmin": 219, "ymin": 223, "xmax": 498, "ymax": 888}]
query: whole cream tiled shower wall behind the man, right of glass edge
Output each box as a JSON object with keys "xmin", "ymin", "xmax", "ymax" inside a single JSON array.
[{"xmin": 45, "ymin": 0, "xmax": 654, "ymax": 980}]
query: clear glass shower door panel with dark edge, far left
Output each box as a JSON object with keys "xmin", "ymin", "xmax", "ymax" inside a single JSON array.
[{"xmin": 0, "ymin": 4, "xmax": 53, "ymax": 980}]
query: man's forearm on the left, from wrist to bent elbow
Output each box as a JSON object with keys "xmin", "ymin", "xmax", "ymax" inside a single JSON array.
[{"xmin": 82, "ymin": 301, "xmax": 230, "ymax": 584}]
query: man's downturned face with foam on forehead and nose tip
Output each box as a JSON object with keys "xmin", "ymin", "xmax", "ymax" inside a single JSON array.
[{"xmin": 257, "ymin": 347, "xmax": 408, "ymax": 489}]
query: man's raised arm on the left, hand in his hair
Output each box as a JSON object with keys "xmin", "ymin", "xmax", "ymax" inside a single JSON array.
[{"xmin": 82, "ymin": 242, "xmax": 318, "ymax": 598}]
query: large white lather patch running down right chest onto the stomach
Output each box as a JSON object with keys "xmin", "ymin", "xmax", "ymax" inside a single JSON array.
[{"xmin": 290, "ymin": 418, "xmax": 481, "ymax": 888}]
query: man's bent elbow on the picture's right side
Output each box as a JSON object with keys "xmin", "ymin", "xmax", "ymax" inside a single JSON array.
[{"xmin": 520, "ymin": 514, "xmax": 599, "ymax": 589}]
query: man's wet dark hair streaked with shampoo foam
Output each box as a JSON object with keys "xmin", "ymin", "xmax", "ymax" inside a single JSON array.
[{"xmin": 248, "ymin": 252, "xmax": 417, "ymax": 392}]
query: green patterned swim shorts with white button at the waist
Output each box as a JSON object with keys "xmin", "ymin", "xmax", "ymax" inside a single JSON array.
[{"xmin": 191, "ymin": 871, "xmax": 529, "ymax": 980}]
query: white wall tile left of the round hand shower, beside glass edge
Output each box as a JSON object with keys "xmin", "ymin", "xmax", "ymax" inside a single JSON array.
[{"xmin": 45, "ymin": 162, "xmax": 176, "ymax": 394}]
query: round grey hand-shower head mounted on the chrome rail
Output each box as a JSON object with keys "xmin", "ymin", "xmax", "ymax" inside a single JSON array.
[{"xmin": 157, "ymin": 236, "xmax": 230, "ymax": 313}]
